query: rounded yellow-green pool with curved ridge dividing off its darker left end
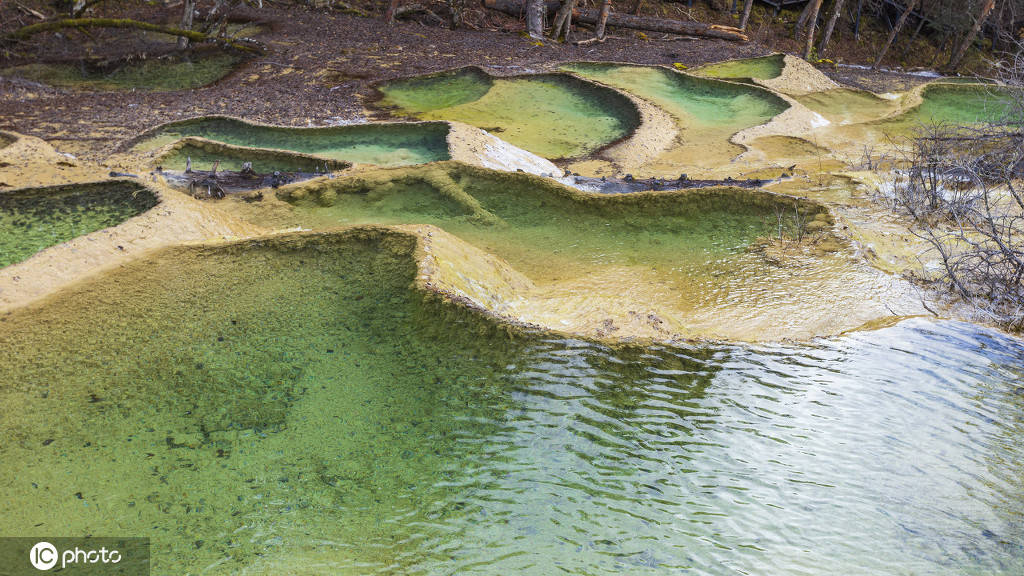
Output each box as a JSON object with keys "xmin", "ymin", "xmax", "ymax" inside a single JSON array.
[{"xmin": 376, "ymin": 69, "xmax": 640, "ymax": 159}]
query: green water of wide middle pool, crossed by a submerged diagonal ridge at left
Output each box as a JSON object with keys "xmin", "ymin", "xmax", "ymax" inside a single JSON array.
[{"xmin": 272, "ymin": 165, "xmax": 815, "ymax": 284}]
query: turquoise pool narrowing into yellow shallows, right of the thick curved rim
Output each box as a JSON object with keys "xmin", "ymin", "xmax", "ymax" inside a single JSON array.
[{"xmin": 563, "ymin": 64, "xmax": 788, "ymax": 170}]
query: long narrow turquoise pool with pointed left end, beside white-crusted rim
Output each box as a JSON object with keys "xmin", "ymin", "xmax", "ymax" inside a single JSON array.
[{"xmin": 132, "ymin": 117, "xmax": 449, "ymax": 166}]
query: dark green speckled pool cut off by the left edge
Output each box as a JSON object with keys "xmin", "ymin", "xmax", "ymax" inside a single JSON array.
[{"xmin": 0, "ymin": 182, "xmax": 159, "ymax": 268}]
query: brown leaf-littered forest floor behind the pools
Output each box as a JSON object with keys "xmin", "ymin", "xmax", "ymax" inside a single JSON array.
[{"xmin": 0, "ymin": 5, "xmax": 942, "ymax": 160}]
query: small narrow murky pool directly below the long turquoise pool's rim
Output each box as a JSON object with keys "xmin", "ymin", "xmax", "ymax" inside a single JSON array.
[{"xmin": 160, "ymin": 143, "xmax": 339, "ymax": 174}]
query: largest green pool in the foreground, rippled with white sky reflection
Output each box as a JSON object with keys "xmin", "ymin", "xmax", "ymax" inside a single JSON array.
[{"xmin": 0, "ymin": 226, "xmax": 1024, "ymax": 575}]
